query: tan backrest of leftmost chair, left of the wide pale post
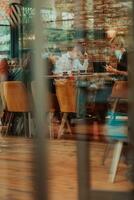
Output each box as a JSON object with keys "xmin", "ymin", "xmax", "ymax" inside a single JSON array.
[{"xmin": 3, "ymin": 81, "xmax": 30, "ymax": 112}]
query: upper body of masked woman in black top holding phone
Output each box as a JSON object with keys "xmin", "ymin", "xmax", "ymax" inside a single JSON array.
[{"xmin": 106, "ymin": 36, "xmax": 128, "ymax": 77}]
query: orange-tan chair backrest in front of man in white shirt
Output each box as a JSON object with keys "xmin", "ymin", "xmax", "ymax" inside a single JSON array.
[{"xmin": 55, "ymin": 79, "xmax": 76, "ymax": 113}]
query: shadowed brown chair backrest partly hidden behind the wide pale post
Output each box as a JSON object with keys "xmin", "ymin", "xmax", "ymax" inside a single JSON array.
[{"xmin": 31, "ymin": 81, "xmax": 58, "ymax": 112}]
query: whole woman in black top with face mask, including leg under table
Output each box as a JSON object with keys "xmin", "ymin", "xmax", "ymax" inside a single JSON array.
[{"xmin": 95, "ymin": 36, "xmax": 128, "ymax": 123}]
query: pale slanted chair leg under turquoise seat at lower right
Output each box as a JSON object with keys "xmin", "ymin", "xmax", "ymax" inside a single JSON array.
[{"xmin": 109, "ymin": 141, "xmax": 123, "ymax": 183}]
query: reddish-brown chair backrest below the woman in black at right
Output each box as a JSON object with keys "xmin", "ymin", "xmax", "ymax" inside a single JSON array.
[{"xmin": 111, "ymin": 81, "xmax": 128, "ymax": 99}]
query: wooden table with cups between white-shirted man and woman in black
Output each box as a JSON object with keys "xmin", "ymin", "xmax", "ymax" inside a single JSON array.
[{"xmin": 44, "ymin": 73, "xmax": 115, "ymax": 118}]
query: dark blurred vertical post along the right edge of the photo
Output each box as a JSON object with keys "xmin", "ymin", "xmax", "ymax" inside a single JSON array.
[{"xmin": 127, "ymin": 0, "xmax": 134, "ymax": 186}]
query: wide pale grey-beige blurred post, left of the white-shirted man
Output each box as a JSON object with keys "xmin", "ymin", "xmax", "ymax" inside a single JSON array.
[{"xmin": 33, "ymin": 0, "xmax": 48, "ymax": 200}]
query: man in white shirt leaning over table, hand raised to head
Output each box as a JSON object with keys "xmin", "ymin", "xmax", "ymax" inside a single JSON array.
[{"xmin": 54, "ymin": 44, "xmax": 88, "ymax": 74}]
